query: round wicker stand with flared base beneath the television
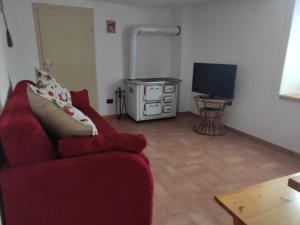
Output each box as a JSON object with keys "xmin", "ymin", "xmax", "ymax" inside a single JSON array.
[{"xmin": 194, "ymin": 95, "xmax": 232, "ymax": 136}]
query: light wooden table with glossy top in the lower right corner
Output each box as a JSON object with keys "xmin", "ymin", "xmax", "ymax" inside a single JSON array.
[{"xmin": 215, "ymin": 173, "xmax": 300, "ymax": 225}]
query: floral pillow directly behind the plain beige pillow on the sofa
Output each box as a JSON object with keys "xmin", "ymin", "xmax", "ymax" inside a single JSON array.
[{"xmin": 29, "ymin": 84, "xmax": 98, "ymax": 135}]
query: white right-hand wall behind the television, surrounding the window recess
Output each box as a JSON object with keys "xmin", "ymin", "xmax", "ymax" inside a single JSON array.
[{"xmin": 186, "ymin": 0, "xmax": 300, "ymax": 152}]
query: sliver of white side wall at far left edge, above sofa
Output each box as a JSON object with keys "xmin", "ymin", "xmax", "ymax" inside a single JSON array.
[{"xmin": 0, "ymin": 13, "xmax": 10, "ymax": 114}]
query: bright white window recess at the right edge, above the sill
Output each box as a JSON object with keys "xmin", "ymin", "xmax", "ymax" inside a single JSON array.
[{"xmin": 280, "ymin": 0, "xmax": 300, "ymax": 94}]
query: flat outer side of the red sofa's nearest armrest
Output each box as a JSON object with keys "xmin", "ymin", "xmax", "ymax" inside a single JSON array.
[{"xmin": 1, "ymin": 152, "xmax": 153, "ymax": 225}]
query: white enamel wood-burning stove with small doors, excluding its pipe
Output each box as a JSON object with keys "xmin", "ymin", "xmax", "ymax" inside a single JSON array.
[{"xmin": 125, "ymin": 78, "xmax": 181, "ymax": 121}]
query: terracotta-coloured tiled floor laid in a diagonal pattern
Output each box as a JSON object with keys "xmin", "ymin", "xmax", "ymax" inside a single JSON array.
[{"xmin": 111, "ymin": 115, "xmax": 300, "ymax": 225}]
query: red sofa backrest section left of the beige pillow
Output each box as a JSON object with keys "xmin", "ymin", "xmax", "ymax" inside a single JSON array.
[{"xmin": 0, "ymin": 81, "xmax": 57, "ymax": 166}]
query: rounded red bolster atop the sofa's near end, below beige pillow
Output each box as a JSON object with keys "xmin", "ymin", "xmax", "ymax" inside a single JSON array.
[{"xmin": 58, "ymin": 133, "xmax": 147, "ymax": 157}]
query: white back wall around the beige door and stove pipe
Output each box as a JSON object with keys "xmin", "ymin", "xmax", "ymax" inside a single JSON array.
[{"xmin": 4, "ymin": 0, "xmax": 176, "ymax": 115}]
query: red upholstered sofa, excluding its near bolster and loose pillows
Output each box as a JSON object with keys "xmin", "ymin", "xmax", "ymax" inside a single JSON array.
[{"xmin": 0, "ymin": 81, "xmax": 153, "ymax": 225}]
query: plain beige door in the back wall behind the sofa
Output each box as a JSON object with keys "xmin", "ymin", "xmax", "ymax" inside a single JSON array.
[{"xmin": 33, "ymin": 3, "xmax": 97, "ymax": 109}]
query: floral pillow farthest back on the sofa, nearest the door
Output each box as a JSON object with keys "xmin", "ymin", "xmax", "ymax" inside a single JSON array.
[{"xmin": 35, "ymin": 68, "xmax": 72, "ymax": 105}]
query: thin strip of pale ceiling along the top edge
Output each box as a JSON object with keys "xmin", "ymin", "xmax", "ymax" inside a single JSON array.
[{"xmin": 94, "ymin": 0, "xmax": 223, "ymax": 7}]
